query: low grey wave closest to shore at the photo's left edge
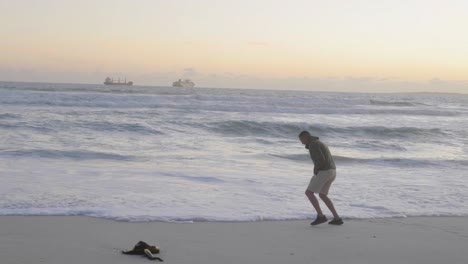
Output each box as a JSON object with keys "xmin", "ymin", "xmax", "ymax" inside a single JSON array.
[{"xmin": 0, "ymin": 149, "xmax": 137, "ymax": 161}]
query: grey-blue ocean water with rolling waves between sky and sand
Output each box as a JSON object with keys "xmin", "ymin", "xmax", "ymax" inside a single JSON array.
[{"xmin": 0, "ymin": 82, "xmax": 468, "ymax": 221}]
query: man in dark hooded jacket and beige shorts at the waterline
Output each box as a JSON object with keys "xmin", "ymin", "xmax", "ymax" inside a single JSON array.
[{"xmin": 299, "ymin": 131, "xmax": 343, "ymax": 225}]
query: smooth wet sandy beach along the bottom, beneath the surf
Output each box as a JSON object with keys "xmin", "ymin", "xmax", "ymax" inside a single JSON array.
[{"xmin": 0, "ymin": 216, "xmax": 468, "ymax": 264}]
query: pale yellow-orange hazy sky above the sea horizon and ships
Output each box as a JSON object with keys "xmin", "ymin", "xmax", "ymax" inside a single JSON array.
[{"xmin": 0, "ymin": 0, "xmax": 468, "ymax": 93}]
